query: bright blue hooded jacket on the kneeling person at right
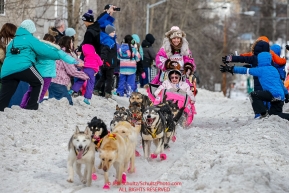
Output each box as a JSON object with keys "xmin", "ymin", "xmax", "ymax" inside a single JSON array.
[{"xmin": 233, "ymin": 52, "xmax": 288, "ymax": 101}]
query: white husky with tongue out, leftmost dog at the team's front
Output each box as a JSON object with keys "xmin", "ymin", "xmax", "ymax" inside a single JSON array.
[{"xmin": 67, "ymin": 126, "xmax": 95, "ymax": 186}]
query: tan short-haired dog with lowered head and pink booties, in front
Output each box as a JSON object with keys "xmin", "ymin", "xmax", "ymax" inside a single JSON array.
[{"xmin": 99, "ymin": 133, "xmax": 135, "ymax": 189}]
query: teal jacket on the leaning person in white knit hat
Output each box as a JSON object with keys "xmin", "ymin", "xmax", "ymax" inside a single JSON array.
[{"xmin": 1, "ymin": 27, "xmax": 70, "ymax": 78}]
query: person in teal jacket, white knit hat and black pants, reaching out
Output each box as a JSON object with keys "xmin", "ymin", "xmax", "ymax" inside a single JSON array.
[{"xmin": 0, "ymin": 19, "xmax": 79, "ymax": 111}]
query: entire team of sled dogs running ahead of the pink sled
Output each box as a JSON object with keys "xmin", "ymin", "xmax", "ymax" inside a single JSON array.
[{"xmin": 67, "ymin": 92, "xmax": 184, "ymax": 189}]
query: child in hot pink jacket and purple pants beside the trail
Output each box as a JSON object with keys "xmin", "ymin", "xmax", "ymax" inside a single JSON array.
[{"xmin": 69, "ymin": 44, "xmax": 103, "ymax": 105}]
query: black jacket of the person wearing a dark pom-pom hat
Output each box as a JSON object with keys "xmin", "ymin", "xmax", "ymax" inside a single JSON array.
[{"xmin": 78, "ymin": 21, "xmax": 101, "ymax": 55}]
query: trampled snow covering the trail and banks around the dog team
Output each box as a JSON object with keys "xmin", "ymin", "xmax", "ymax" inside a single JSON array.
[{"xmin": 0, "ymin": 89, "xmax": 289, "ymax": 193}]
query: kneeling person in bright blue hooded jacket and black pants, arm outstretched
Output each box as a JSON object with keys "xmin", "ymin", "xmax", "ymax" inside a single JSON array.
[{"xmin": 220, "ymin": 52, "xmax": 289, "ymax": 120}]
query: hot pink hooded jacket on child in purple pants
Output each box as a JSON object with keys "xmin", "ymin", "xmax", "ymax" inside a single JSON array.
[{"xmin": 82, "ymin": 44, "xmax": 102, "ymax": 72}]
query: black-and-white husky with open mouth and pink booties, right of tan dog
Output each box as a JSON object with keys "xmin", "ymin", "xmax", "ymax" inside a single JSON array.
[{"xmin": 141, "ymin": 106, "xmax": 166, "ymax": 160}]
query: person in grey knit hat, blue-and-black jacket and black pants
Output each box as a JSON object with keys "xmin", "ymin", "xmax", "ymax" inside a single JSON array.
[{"xmin": 94, "ymin": 25, "xmax": 117, "ymax": 98}]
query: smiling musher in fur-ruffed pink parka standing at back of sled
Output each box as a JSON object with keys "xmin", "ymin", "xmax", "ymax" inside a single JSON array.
[{"xmin": 151, "ymin": 26, "xmax": 196, "ymax": 84}]
